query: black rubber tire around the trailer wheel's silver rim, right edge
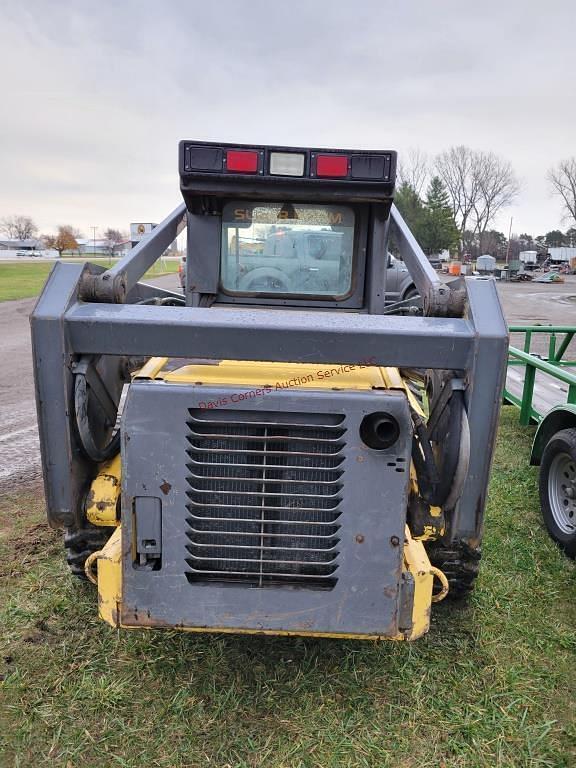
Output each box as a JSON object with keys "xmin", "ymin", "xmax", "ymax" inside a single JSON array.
[{"xmin": 539, "ymin": 429, "xmax": 576, "ymax": 558}]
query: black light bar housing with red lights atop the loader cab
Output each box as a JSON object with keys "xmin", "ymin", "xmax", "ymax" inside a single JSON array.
[{"xmin": 179, "ymin": 141, "xmax": 397, "ymax": 213}]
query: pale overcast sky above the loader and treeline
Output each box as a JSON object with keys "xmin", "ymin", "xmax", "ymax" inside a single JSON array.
[{"xmin": 0, "ymin": 0, "xmax": 576, "ymax": 235}]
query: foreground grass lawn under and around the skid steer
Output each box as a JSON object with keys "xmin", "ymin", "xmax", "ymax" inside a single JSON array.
[{"xmin": 0, "ymin": 408, "xmax": 576, "ymax": 768}]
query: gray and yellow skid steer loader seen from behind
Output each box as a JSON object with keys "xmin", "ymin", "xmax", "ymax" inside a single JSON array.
[{"xmin": 31, "ymin": 141, "xmax": 507, "ymax": 640}]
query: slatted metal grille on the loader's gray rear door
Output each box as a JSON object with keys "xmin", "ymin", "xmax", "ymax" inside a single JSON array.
[{"xmin": 186, "ymin": 409, "xmax": 346, "ymax": 589}]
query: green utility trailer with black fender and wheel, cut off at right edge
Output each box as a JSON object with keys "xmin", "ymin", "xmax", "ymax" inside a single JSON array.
[{"xmin": 504, "ymin": 325, "xmax": 576, "ymax": 557}]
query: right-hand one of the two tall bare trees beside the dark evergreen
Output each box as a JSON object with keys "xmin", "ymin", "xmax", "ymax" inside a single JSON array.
[{"xmin": 474, "ymin": 152, "xmax": 520, "ymax": 251}]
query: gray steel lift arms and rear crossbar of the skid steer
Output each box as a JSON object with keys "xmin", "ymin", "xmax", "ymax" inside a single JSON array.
[{"xmin": 31, "ymin": 200, "xmax": 507, "ymax": 542}]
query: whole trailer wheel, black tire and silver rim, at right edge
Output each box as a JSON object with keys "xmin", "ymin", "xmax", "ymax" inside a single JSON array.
[{"xmin": 540, "ymin": 429, "xmax": 576, "ymax": 557}]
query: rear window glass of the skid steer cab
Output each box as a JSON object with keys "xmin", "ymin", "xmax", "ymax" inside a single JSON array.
[{"xmin": 220, "ymin": 201, "xmax": 354, "ymax": 298}]
